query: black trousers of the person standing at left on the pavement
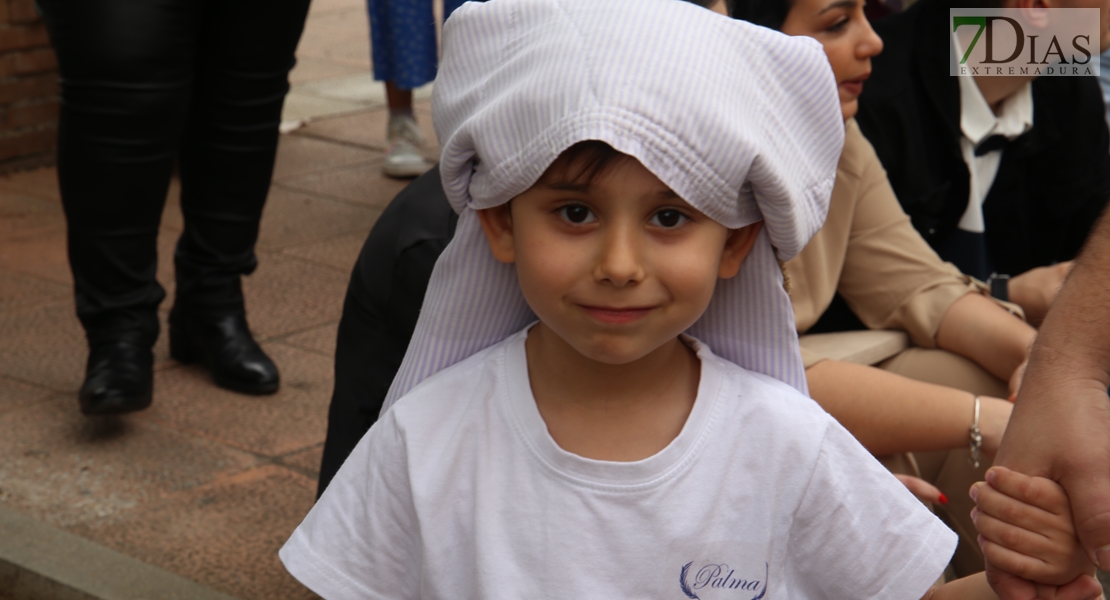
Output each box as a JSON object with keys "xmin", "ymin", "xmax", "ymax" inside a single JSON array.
[{"xmin": 40, "ymin": 0, "xmax": 309, "ymax": 344}]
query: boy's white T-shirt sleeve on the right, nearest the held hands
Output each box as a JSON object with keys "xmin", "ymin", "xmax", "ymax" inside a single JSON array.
[{"xmin": 786, "ymin": 424, "xmax": 956, "ymax": 600}]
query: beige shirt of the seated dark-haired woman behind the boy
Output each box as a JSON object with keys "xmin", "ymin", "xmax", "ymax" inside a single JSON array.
[{"xmin": 786, "ymin": 120, "xmax": 985, "ymax": 368}]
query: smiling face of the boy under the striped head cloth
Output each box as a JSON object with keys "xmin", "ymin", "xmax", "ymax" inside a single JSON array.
[{"xmin": 478, "ymin": 149, "xmax": 759, "ymax": 365}]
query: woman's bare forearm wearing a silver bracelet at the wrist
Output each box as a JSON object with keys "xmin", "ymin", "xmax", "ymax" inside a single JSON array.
[{"xmin": 806, "ymin": 360, "xmax": 1011, "ymax": 458}]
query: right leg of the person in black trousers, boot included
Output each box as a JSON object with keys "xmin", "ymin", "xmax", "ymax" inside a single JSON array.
[{"xmin": 170, "ymin": 0, "xmax": 309, "ymax": 394}]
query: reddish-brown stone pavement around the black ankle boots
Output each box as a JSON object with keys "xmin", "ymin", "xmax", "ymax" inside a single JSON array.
[{"xmin": 0, "ymin": 0, "xmax": 437, "ymax": 599}]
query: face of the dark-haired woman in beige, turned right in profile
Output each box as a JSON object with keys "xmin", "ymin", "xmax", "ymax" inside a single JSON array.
[{"xmin": 783, "ymin": 0, "xmax": 882, "ymax": 121}]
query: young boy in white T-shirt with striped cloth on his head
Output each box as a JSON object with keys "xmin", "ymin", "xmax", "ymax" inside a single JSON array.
[{"xmin": 282, "ymin": 0, "xmax": 1096, "ymax": 599}]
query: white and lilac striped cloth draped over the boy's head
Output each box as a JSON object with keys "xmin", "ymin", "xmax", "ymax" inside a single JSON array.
[{"xmin": 383, "ymin": 0, "xmax": 844, "ymax": 411}]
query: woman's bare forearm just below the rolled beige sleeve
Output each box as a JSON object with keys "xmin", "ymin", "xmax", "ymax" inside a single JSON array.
[{"xmin": 937, "ymin": 294, "xmax": 1037, "ymax": 382}]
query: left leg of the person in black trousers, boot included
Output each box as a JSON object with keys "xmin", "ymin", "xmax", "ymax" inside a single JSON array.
[{"xmin": 40, "ymin": 0, "xmax": 199, "ymax": 414}]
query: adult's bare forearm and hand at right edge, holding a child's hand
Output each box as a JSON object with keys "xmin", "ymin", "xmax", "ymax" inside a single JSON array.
[{"xmin": 997, "ymin": 206, "xmax": 1110, "ymax": 576}]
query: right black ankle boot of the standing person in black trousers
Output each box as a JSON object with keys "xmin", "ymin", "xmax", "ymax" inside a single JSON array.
[{"xmin": 170, "ymin": 306, "xmax": 280, "ymax": 394}]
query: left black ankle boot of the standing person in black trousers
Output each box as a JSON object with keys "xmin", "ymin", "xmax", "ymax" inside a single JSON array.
[{"xmin": 78, "ymin": 339, "xmax": 154, "ymax": 415}]
